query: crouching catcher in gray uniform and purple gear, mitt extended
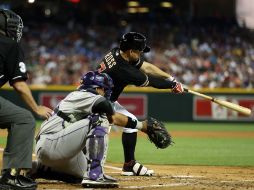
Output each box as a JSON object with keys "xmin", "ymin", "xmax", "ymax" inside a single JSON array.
[{"xmin": 30, "ymin": 72, "xmax": 171, "ymax": 188}]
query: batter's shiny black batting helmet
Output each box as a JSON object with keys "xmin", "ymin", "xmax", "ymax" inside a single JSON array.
[{"xmin": 120, "ymin": 32, "xmax": 150, "ymax": 53}]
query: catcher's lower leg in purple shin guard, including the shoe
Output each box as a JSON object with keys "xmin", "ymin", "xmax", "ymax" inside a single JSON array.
[{"xmin": 81, "ymin": 121, "xmax": 119, "ymax": 188}]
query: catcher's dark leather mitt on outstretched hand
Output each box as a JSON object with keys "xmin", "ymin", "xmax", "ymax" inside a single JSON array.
[{"xmin": 146, "ymin": 117, "xmax": 173, "ymax": 148}]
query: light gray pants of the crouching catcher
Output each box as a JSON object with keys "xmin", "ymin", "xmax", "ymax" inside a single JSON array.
[{"xmin": 35, "ymin": 119, "xmax": 89, "ymax": 178}]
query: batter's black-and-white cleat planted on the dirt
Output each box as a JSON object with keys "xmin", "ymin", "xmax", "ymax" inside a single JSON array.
[{"xmin": 121, "ymin": 160, "xmax": 154, "ymax": 176}]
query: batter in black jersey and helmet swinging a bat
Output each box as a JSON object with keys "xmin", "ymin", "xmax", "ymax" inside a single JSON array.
[{"xmin": 98, "ymin": 32, "xmax": 183, "ymax": 176}]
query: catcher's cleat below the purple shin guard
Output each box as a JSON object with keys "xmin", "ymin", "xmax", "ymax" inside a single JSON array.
[{"xmin": 81, "ymin": 174, "xmax": 119, "ymax": 188}]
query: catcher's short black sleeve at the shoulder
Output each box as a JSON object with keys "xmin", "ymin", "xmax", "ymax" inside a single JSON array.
[{"xmin": 92, "ymin": 97, "xmax": 114, "ymax": 115}]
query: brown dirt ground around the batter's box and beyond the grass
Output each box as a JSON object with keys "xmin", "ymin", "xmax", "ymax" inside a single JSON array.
[{"xmin": 0, "ymin": 131, "xmax": 254, "ymax": 190}]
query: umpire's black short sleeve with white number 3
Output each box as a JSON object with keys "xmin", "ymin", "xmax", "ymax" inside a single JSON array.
[{"xmin": 7, "ymin": 43, "xmax": 27, "ymax": 85}]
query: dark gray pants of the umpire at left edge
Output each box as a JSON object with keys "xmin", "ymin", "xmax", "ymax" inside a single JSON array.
[{"xmin": 0, "ymin": 96, "xmax": 35, "ymax": 169}]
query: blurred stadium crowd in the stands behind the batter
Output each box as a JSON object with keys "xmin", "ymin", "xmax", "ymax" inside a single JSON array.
[{"xmin": 22, "ymin": 21, "xmax": 254, "ymax": 88}]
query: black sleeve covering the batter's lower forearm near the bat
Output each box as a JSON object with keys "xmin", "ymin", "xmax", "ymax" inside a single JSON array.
[{"xmin": 147, "ymin": 75, "xmax": 176, "ymax": 89}]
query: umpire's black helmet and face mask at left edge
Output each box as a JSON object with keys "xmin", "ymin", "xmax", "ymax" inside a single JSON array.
[{"xmin": 0, "ymin": 8, "xmax": 23, "ymax": 42}]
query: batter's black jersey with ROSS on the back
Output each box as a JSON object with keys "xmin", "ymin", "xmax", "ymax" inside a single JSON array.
[{"xmin": 98, "ymin": 48, "xmax": 148, "ymax": 101}]
